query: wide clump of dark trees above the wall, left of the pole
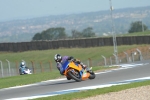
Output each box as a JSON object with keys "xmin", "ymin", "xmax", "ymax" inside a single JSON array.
[{"xmin": 32, "ymin": 27, "xmax": 96, "ymax": 40}]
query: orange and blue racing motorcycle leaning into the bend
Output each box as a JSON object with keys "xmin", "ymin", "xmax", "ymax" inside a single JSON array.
[{"xmin": 62, "ymin": 61, "xmax": 95, "ymax": 82}]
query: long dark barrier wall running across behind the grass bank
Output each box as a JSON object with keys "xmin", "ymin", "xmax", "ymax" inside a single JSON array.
[{"xmin": 0, "ymin": 36, "xmax": 150, "ymax": 52}]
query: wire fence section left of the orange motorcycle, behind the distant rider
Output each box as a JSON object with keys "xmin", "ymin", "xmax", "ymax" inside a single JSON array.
[{"xmin": 0, "ymin": 60, "xmax": 56, "ymax": 77}]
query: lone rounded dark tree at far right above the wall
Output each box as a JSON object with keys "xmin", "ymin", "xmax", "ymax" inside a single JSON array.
[{"xmin": 128, "ymin": 21, "xmax": 148, "ymax": 33}]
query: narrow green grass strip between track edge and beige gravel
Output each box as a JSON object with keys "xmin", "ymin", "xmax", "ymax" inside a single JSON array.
[{"xmin": 36, "ymin": 80, "xmax": 150, "ymax": 100}]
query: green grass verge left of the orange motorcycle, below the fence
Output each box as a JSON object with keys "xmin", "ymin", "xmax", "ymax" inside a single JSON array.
[{"xmin": 0, "ymin": 71, "xmax": 60, "ymax": 89}]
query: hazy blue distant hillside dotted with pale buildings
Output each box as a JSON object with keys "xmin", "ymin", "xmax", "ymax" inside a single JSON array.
[{"xmin": 0, "ymin": 6, "xmax": 150, "ymax": 42}]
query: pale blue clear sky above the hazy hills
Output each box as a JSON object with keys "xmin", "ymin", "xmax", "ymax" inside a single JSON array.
[{"xmin": 0, "ymin": 0, "xmax": 150, "ymax": 22}]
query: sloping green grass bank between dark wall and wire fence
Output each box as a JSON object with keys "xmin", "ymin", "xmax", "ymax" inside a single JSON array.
[{"xmin": 0, "ymin": 45, "xmax": 144, "ymax": 63}]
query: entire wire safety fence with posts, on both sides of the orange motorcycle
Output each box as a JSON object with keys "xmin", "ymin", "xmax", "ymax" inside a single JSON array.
[{"xmin": 0, "ymin": 47, "xmax": 150, "ymax": 78}]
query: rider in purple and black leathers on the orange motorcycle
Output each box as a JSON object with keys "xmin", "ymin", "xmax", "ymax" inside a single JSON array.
[{"xmin": 54, "ymin": 54, "xmax": 87, "ymax": 80}]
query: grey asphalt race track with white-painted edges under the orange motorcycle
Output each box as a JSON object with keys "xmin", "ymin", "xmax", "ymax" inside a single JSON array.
[{"xmin": 0, "ymin": 60, "xmax": 150, "ymax": 100}]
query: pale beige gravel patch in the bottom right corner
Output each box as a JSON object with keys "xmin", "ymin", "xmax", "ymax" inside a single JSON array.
[{"xmin": 73, "ymin": 85, "xmax": 150, "ymax": 100}]
